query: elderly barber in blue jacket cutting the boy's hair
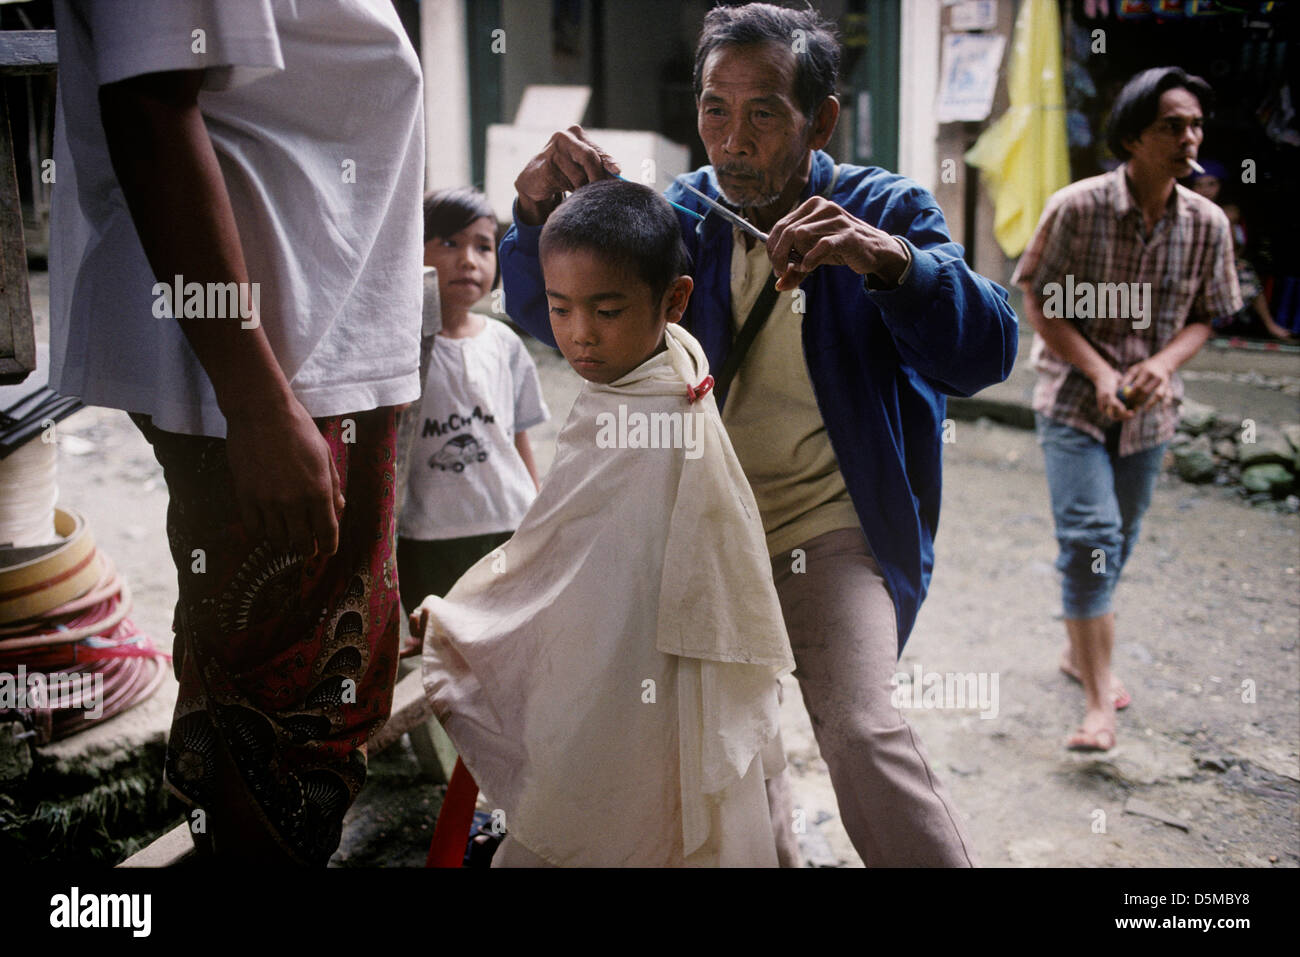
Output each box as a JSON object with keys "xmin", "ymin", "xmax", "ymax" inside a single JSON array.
[{"xmin": 502, "ymin": 4, "xmax": 1017, "ymax": 866}]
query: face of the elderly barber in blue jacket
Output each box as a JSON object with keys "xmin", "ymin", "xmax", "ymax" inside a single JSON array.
[{"xmin": 697, "ymin": 43, "xmax": 813, "ymax": 208}]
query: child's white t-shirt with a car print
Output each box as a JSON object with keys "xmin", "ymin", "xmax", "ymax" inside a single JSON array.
[{"xmin": 398, "ymin": 319, "xmax": 550, "ymax": 541}]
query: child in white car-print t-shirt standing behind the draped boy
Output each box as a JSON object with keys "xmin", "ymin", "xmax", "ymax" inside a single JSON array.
[{"xmin": 398, "ymin": 189, "xmax": 549, "ymax": 642}]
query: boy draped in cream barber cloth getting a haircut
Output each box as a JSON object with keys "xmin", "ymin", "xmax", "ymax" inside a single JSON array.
[{"xmin": 412, "ymin": 179, "xmax": 794, "ymax": 867}]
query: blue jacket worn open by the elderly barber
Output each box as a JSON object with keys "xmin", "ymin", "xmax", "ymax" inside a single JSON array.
[{"xmin": 501, "ymin": 151, "xmax": 1018, "ymax": 653}]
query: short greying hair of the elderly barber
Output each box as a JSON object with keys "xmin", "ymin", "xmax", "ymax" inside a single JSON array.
[{"xmin": 694, "ymin": 4, "xmax": 840, "ymax": 120}]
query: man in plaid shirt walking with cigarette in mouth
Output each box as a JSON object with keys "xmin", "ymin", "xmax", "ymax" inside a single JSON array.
[{"xmin": 1011, "ymin": 66, "xmax": 1242, "ymax": 750}]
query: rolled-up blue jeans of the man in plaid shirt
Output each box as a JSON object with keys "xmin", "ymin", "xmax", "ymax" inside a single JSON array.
[{"xmin": 1035, "ymin": 413, "xmax": 1167, "ymax": 619}]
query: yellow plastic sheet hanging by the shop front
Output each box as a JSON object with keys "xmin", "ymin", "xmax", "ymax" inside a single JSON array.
[{"xmin": 966, "ymin": 0, "xmax": 1070, "ymax": 259}]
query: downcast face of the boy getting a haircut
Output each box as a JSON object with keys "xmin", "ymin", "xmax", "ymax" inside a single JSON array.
[{"xmin": 542, "ymin": 250, "xmax": 692, "ymax": 384}]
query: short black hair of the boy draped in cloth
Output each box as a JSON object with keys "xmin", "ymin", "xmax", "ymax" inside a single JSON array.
[{"xmin": 540, "ymin": 179, "xmax": 688, "ymax": 303}]
